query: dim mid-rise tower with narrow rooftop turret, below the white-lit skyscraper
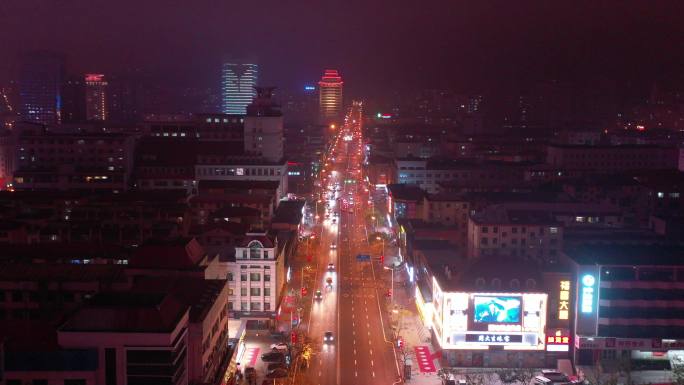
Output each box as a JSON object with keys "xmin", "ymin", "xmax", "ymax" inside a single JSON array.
[{"xmin": 244, "ymin": 87, "xmax": 285, "ymax": 162}]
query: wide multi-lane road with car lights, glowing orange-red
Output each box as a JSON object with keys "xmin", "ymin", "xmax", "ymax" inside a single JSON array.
[{"xmin": 298, "ymin": 104, "xmax": 399, "ymax": 385}]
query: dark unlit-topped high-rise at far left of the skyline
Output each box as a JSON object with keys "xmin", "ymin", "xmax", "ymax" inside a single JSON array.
[{"xmin": 19, "ymin": 52, "xmax": 64, "ymax": 124}]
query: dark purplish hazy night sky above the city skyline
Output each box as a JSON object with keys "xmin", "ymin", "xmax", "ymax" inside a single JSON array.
[{"xmin": 0, "ymin": 0, "xmax": 684, "ymax": 93}]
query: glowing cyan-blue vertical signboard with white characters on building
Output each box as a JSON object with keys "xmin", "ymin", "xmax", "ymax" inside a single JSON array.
[{"xmin": 575, "ymin": 266, "xmax": 600, "ymax": 336}]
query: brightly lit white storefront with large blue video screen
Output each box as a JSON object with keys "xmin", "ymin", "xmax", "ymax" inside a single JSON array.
[{"xmin": 432, "ymin": 277, "xmax": 548, "ymax": 367}]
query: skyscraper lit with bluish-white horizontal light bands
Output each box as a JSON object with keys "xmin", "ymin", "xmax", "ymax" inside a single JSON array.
[{"xmin": 221, "ymin": 61, "xmax": 259, "ymax": 115}]
